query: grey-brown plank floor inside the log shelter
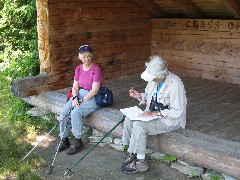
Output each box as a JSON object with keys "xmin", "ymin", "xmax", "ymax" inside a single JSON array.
[{"xmin": 104, "ymin": 75, "xmax": 240, "ymax": 141}]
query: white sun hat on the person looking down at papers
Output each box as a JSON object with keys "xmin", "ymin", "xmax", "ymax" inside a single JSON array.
[{"xmin": 141, "ymin": 56, "xmax": 168, "ymax": 81}]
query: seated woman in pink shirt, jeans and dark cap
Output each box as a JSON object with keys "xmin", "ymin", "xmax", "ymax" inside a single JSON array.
[{"xmin": 59, "ymin": 45, "xmax": 103, "ymax": 155}]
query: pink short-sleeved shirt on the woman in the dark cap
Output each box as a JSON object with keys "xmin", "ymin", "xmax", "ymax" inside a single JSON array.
[{"xmin": 74, "ymin": 64, "xmax": 104, "ymax": 90}]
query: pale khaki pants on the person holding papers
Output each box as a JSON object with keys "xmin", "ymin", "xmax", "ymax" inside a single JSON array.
[{"xmin": 122, "ymin": 117, "xmax": 181, "ymax": 155}]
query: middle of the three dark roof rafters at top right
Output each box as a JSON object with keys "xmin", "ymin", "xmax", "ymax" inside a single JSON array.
[{"xmin": 172, "ymin": 0, "xmax": 204, "ymax": 18}]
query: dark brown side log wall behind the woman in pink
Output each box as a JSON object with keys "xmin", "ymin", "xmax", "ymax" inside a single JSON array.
[{"xmin": 37, "ymin": 0, "xmax": 151, "ymax": 78}]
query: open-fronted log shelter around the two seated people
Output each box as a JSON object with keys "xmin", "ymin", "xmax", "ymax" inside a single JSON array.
[{"xmin": 11, "ymin": 0, "xmax": 240, "ymax": 178}]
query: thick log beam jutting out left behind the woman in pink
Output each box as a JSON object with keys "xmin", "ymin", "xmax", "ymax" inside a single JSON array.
[{"xmin": 11, "ymin": 73, "xmax": 73, "ymax": 98}]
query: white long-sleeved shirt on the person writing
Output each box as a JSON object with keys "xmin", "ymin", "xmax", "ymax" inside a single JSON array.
[{"xmin": 140, "ymin": 72, "xmax": 187, "ymax": 129}]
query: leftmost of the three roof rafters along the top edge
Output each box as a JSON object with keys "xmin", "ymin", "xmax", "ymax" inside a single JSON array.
[{"xmin": 135, "ymin": 0, "xmax": 167, "ymax": 17}]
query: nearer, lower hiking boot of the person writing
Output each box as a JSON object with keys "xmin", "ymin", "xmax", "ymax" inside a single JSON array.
[{"xmin": 121, "ymin": 159, "xmax": 148, "ymax": 174}]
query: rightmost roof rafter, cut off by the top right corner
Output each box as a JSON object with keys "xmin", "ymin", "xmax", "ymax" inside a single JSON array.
[{"xmin": 222, "ymin": 0, "xmax": 240, "ymax": 19}]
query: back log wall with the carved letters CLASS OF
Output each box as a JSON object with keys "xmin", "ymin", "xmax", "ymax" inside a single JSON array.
[{"xmin": 151, "ymin": 19, "xmax": 240, "ymax": 84}]
